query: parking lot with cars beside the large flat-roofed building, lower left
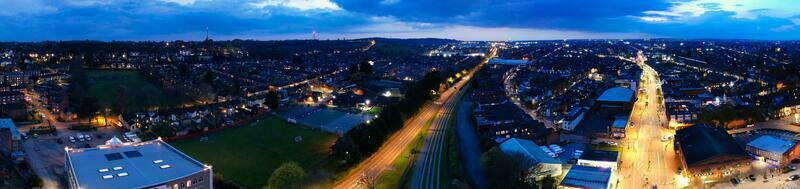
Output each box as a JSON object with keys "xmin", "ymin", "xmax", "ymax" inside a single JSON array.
[{"xmin": 20, "ymin": 126, "xmax": 123, "ymax": 188}]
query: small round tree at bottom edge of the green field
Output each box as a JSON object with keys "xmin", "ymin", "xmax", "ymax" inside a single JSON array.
[{"xmin": 266, "ymin": 162, "xmax": 306, "ymax": 189}]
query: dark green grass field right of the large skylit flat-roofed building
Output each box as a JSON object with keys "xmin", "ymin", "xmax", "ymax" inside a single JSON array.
[{"xmin": 171, "ymin": 116, "xmax": 336, "ymax": 188}]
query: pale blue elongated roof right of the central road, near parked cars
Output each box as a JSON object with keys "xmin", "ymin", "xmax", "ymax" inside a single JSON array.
[{"xmin": 500, "ymin": 138, "xmax": 561, "ymax": 164}]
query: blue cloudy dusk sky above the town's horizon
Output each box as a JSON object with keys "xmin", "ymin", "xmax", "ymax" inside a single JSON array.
[{"xmin": 0, "ymin": 0, "xmax": 800, "ymax": 41}]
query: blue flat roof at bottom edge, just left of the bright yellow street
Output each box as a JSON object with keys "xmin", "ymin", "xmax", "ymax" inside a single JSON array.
[{"xmin": 559, "ymin": 165, "xmax": 611, "ymax": 189}]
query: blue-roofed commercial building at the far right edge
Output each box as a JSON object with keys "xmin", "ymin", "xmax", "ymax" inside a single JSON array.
[{"xmin": 745, "ymin": 135, "xmax": 800, "ymax": 166}]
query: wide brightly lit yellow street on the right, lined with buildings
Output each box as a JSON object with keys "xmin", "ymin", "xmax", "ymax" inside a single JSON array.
[{"xmin": 615, "ymin": 51, "xmax": 688, "ymax": 188}]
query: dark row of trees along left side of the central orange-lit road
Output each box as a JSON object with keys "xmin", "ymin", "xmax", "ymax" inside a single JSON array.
[{"xmin": 331, "ymin": 71, "xmax": 443, "ymax": 167}]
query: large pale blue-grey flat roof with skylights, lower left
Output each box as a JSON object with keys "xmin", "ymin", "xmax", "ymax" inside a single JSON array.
[{"xmin": 66, "ymin": 139, "xmax": 210, "ymax": 188}]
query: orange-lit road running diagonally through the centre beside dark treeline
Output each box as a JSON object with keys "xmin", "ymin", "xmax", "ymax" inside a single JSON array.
[{"xmin": 333, "ymin": 50, "xmax": 496, "ymax": 189}]
